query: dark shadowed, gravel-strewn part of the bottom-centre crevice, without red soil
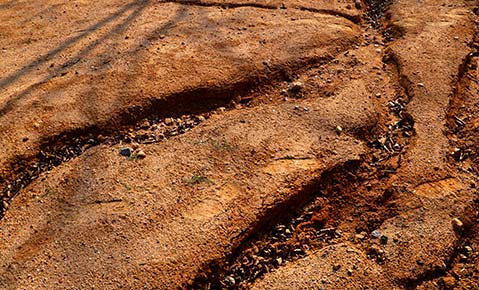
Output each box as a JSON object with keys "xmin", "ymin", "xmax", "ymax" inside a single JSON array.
[{"xmin": 186, "ymin": 160, "xmax": 363, "ymax": 289}]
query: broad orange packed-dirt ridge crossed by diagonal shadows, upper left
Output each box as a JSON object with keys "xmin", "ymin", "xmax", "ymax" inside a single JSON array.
[{"xmin": 0, "ymin": 1, "xmax": 358, "ymax": 206}]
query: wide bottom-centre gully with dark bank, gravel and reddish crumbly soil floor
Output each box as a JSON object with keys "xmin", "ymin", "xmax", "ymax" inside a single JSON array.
[{"xmin": 187, "ymin": 82, "xmax": 414, "ymax": 289}]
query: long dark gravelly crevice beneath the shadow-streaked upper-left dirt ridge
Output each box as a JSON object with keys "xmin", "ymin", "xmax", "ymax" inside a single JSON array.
[{"xmin": 0, "ymin": 56, "xmax": 344, "ymax": 218}]
